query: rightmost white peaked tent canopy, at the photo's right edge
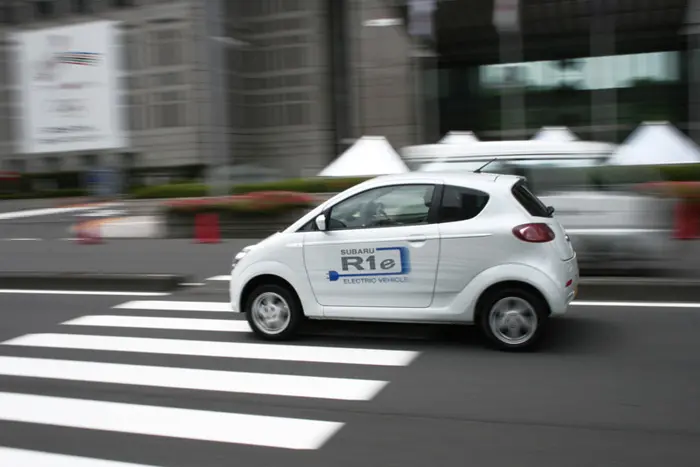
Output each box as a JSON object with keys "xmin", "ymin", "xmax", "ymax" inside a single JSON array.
[{"xmin": 608, "ymin": 122, "xmax": 700, "ymax": 165}]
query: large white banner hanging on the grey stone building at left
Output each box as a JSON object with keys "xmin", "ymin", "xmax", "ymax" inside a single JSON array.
[{"xmin": 14, "ymin": 21, "xmax": 126, "ymax": 154}]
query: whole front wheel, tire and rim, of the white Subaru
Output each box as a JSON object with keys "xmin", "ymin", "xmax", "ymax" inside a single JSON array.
[{"xmin": 245, "ymin": 284, "xmax": 304, "ymax": 340}]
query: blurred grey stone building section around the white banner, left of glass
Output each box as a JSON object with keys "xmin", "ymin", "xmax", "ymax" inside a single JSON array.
[{"xmin": 0, "ymin": 0, "xmax": 420, "ymax": 176}]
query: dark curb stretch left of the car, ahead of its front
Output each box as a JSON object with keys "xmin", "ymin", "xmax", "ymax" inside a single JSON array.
[{"xmin": 0, "ymin": 272, "xmax": 187, "ymax": 292}]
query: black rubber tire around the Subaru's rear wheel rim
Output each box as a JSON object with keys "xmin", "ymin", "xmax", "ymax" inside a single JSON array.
[{"xmin": 477, "ymin": 287, "xmax": 549, "ymax": 351}]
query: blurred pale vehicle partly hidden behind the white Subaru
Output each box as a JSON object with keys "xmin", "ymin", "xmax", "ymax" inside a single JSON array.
[{"xmin": 409, "ymin": 141, "xmax": 672, "ymax": 274}]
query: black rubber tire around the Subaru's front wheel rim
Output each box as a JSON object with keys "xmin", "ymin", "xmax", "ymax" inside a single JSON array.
[{"xmin": 244, "ymin": 284, "xmax": 304, "ymax": 341}]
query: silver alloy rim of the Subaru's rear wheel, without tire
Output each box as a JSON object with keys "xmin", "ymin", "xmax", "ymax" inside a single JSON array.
[{"xmin": 489, "ymin": 297, "xmax": 539, "ymax": 345}]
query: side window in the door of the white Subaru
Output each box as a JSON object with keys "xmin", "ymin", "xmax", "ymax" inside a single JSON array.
[{"xmin": 328, "ymin": 185, "xmax": 435, "ymax": 230}]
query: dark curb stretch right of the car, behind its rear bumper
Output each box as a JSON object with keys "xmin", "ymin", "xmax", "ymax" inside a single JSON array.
[{"xmin": 576, "ymin": 277, "xmax": 700, "ymax": 303}]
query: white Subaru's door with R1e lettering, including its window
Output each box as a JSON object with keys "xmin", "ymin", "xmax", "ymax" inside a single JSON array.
[{"xmin": 304, "ymin": 183, "xmax": 440, "ymax": 308}]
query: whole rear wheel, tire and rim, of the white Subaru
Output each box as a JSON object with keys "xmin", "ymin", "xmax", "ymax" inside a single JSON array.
[{"xmin": 479, "ymin": 289, "xmax": 549, "ymax": 351}]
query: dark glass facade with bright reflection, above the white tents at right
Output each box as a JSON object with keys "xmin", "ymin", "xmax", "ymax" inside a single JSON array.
[{"xmin": 439, "ymin": 51, "xmax": 688, "ymax": 141}]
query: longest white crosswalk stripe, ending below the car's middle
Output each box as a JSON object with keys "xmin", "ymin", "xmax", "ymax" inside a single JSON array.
[{"xmin": 2, "ymin": 333, "xmax": 419, "ymax": 366}]
